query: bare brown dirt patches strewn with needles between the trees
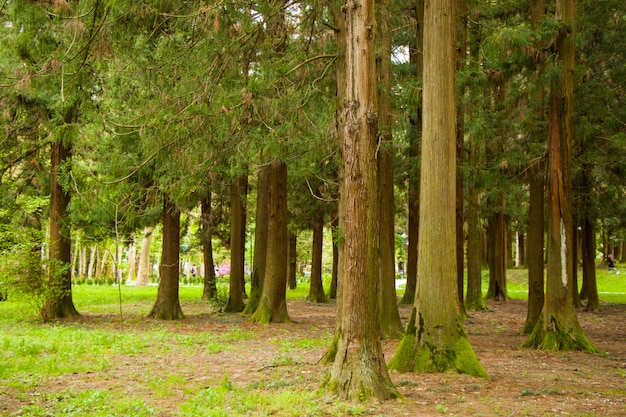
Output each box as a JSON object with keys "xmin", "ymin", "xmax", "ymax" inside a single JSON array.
[{"xmin": 4, "ymin": 300, "xmax": 626, "ymax": 417}]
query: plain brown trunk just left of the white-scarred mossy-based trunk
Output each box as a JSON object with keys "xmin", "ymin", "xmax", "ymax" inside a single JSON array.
[{"xmin": 522, "ymin": 172, "xmax": 544, "ymax": 334}]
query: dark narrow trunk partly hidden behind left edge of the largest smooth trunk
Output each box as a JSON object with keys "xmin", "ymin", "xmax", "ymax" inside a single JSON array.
[{"xmin": 400, "ymin": 0, "xmax": 424, "ymax": 305}]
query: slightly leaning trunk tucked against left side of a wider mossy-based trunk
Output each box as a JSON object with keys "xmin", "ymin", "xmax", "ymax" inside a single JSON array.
[{"xmin": 243, "ymin": 166, "xmax": 269, "ymax": 314}]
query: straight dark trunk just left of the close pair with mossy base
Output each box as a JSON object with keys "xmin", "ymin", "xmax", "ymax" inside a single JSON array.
[{"xmin": 224, "ymin": 174, "xmax": 247, "ymax": 313}]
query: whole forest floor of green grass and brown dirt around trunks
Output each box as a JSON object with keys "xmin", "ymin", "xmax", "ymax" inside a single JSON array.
[{"xmin": 0, "ymin": 271, "xmax": 626, "ymax": 417}]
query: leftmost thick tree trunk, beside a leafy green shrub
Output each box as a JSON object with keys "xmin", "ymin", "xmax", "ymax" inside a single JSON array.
[{"xmin": 41, "ymin": 125, "xmax": 79, "ymax": 321}]
